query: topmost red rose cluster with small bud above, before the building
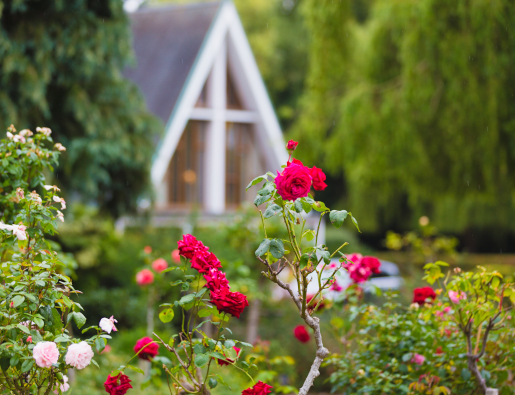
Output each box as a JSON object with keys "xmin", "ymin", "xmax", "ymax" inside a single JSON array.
[{"xmin": 275, "ymin": 152, "xmax": 327, "ymax": 200}]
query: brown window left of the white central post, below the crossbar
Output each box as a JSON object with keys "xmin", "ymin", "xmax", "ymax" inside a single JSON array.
[{"xmin": 168, "ymin": 121, "xmax": 206, "ymax": 207}]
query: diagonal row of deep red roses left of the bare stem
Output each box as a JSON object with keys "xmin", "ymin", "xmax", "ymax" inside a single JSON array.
[{"xmin": 177, "ymin": 235, "xmax": 249, "ymax": 318}]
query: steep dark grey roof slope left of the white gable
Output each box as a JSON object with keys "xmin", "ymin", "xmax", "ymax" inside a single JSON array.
[{"xmin": 124, "ymin": 2, "xmax": 220, "ymax": 124}]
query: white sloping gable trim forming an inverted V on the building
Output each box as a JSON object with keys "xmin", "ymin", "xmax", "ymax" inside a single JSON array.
[{"xmin": 151, "ymin": 1, "xmax": 288, "ymax": 189}]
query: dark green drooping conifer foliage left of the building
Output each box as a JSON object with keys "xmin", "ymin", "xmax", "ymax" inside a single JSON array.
[{"xmin": 0, "ymin": 0, "xmax": 160, "ymax": 215}]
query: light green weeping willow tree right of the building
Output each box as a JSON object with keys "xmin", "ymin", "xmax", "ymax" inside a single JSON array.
[{"xmin": 295, "ymin": 0, "xmax": 515, "ymax": 248}]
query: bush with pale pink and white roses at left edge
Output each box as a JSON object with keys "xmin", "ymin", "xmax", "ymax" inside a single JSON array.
[{"xmin": 0, "ymin": 126, "xmax": 114, "ymax": 395}]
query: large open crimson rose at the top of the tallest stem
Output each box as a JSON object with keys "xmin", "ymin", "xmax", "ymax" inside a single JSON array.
[{"xmin": 275, "ymin": 163, "xmax": 312, "ymax": 200}]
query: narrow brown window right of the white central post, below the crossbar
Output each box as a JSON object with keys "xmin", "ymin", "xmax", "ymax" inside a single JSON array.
[{"xmin": 225, "ymin": 123, "xmax": 252, "ymax": 207}]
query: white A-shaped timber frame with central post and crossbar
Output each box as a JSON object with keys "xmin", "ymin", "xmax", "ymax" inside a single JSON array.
[{"xmin": 151, "ymin": 1, "xmax": 288, "ymax": 214}]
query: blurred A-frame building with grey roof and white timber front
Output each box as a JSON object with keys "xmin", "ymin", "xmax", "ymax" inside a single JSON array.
[{"xmin": 125, "ymin": 1, "xmax": 288, "ymax": 216}]
